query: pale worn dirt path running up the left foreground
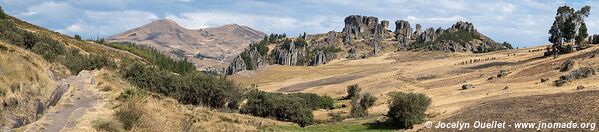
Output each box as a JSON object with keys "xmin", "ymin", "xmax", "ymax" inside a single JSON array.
[{"xmin": 42, "ymin": 71, "xmax": 97, "ymax": 132}]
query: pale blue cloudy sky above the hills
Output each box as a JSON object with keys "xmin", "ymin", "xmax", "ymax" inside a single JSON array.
[{"xmin": 0, "ymin": 0, "xmax": 599, "ymax": 47}]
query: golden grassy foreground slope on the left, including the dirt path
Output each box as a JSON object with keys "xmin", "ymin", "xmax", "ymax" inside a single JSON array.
[{"xmin": 0, "ymin": 11, "xmax": 289, "ymax": 131}]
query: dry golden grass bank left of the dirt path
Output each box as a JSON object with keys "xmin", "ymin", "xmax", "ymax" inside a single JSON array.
[{"xmin": 0, "ymin": 42, "xmax": 69, "ymax": 126}]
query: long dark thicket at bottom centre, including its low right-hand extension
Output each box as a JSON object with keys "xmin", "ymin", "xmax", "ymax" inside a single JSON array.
[{"xmin": 241, "ymin": 90, "xmax": 333, "ymax": 127}]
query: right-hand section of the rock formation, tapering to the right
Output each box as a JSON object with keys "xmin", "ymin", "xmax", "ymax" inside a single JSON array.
[{"xmin": 395, "ymin": 20, "xmax": 511, "ymax": 53}]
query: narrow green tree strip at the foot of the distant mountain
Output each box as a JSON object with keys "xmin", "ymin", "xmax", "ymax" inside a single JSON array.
[{"xmin": 106, "ymin": 43, "xmax": 196, "ymax": 74}]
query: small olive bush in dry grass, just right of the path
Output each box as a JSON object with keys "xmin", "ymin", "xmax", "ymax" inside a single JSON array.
[{"xmin": 115, "ymin": 101, "xmax": 144, "ymax": 130}]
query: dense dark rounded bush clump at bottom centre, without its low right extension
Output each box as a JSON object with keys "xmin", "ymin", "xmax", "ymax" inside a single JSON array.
[{"xmin": 241, "ymin": 91, "xmax": 313, "ymax": 127}]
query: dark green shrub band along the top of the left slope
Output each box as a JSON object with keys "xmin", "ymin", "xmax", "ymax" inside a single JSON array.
[{"xmin": 0, "ymin": 8, "xmax": 113, "ymax": 74}]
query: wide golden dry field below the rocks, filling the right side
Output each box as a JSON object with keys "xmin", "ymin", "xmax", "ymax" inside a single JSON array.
[{"xmin": 231, "ymin": 46, "xmax": 599, "ymax": 130}]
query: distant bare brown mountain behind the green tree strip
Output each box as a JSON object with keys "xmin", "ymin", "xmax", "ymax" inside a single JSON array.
[{"xmin": 108, "ymin": 19, "xmax": 266, "ymax": 68}]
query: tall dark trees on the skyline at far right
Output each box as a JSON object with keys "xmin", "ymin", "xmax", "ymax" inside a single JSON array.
[{"xmin": 545, "ymin": 5, "xmax": 591, "ymax": 56}]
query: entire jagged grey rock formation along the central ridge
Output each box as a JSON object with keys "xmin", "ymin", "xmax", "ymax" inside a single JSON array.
[{"xmin": 227, "ymin": 15, "xmax": 511, "ymax": 74}]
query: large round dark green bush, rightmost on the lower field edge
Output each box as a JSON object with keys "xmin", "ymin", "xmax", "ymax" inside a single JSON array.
[{"xmin": 387, "ymin": 92, "xmax": 431, "ymax": 129}]
